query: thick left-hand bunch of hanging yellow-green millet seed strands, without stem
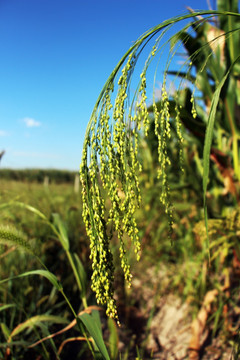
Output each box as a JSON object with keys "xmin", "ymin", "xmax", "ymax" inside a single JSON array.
[{"xmin": 80, "ymin": 54, "xmax": 144, "ymax": 318}]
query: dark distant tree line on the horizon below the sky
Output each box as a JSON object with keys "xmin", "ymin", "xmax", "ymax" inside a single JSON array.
[{"xmin": 0, "ymin": 169, "xmax": 76, "ymax": 184}]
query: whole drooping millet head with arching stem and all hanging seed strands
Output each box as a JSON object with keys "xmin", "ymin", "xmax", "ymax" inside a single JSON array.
[{"xmin": 80, "ymin": 11, "xmax": 239, "ymax": 320}]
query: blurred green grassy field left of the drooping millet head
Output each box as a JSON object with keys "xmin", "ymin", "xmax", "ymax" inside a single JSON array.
[{"xmin": 0, "ymin": 180, "xmax": 94, "ymax": 359}]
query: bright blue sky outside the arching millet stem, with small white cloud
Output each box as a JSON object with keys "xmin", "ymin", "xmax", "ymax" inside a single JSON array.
[{"xmin": 0, "ymin": 0, "xmax": 215, "ymax": 171}]
